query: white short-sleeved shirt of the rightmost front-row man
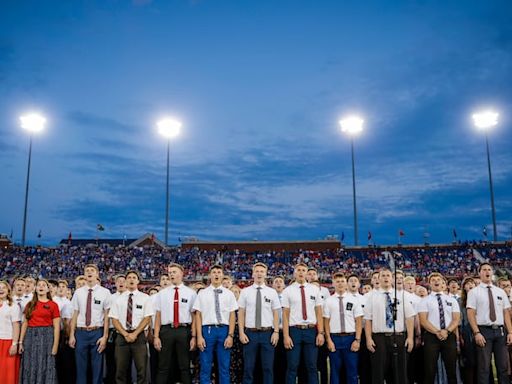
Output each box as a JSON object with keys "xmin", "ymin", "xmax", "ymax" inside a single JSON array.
[{"xmin": 466, "ymin": 283, "xmax": 510, "ymax": 325}]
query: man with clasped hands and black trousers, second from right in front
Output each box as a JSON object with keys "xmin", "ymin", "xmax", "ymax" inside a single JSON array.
[{"xmin": 418, "ymin": 273, "xmax": 460, "ymax": 384}]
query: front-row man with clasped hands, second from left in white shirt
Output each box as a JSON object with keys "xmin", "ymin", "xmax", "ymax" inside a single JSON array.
[{"xmin": 109, "ymin": 271, "xmax": 153, "ymax": 384}]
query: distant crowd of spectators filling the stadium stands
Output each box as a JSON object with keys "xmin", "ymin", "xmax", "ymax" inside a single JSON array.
[{"xmin": 0, "ymin": 242, "xmax": 512, "ymax": 287}]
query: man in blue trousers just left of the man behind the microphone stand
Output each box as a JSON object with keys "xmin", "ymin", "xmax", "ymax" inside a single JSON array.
[{"xmin": 323, "ymin": 273, "xmax": 363, "ymax": 384}]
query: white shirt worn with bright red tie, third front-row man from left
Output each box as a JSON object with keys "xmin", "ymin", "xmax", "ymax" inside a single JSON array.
[{"xmin": 154, "ymin": 284, "xmax": 197, "ymax": 325}]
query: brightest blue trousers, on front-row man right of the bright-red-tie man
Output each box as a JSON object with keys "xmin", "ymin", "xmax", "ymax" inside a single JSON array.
[{"xmin": 199, "ymin": 325, "xmax": 231, "ymax": 384}]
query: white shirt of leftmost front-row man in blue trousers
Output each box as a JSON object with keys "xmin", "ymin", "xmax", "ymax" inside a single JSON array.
[{"xmin": 71, "ymin": 284, "xmax": 112, "ymax": 327}]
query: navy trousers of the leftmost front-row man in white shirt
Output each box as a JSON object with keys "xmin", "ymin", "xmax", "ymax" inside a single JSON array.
[{"xmin": 75, "ymin": 328, "xmax": 103, "ymax": 384}]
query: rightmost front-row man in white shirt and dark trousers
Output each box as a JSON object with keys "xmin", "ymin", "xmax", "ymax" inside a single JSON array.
[{"xmin": 466, "ymin": 263, "xmax": 512, "ymax": 384}]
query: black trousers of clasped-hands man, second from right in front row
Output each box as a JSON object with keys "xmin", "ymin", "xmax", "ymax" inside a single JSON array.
[{"xmin": 423, "ymin": 332, "xmax": 457, "ymax": 384}]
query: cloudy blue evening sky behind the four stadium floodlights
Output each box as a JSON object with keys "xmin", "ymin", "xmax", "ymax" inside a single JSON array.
[{"xmin": 0, "ymin": 0, "xmax": 512, "ymax": 244}]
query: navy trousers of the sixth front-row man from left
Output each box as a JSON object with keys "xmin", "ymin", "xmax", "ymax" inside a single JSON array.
[{"xmin": 286, "ymin": 327, "xmax": 318, "ymax": 384}]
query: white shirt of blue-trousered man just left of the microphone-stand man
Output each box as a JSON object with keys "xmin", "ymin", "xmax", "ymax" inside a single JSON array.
[{"xmin": 323, "ymin": 292, "xmax": 363, "ymax": 333}]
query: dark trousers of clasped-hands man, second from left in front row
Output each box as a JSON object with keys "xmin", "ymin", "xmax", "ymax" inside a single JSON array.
[{"xmin": 115, "ymin": 332, "xmax": 148, "ymax": 384}]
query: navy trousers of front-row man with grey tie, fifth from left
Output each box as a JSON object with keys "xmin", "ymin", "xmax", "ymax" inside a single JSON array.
[{"xmin": 244, "ymin": 330, "xmax": 274, "ymax": 384}]
